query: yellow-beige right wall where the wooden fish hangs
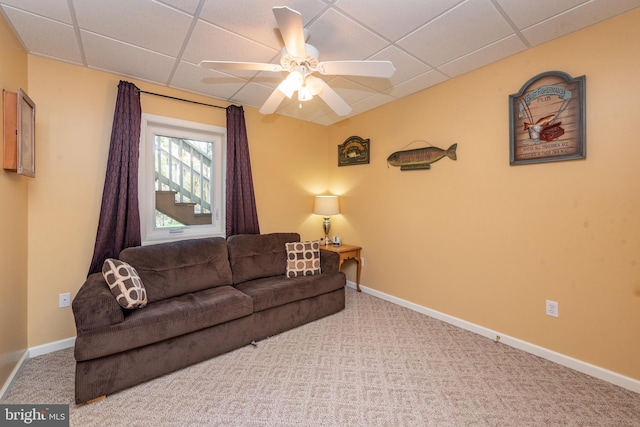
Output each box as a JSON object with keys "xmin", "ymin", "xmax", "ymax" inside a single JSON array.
[{"xmin": 329, "ymin": 9, "xmax": 640, "ymax": 380}]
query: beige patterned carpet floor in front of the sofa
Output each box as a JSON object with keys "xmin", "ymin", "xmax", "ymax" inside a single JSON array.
[{"xmin": 1, "ymin": 288, "xmax": 640, "ymax": 426}]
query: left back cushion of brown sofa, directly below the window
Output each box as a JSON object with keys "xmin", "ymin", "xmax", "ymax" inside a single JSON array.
[{"xmin": 119, "ymin": 237, "xmax": 232, "ymax": 303}]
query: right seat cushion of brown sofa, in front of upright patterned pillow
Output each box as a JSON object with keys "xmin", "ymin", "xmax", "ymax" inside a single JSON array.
[{"xmin": 236, "ymin": 273, "xmax": 347, "ymax": 312}]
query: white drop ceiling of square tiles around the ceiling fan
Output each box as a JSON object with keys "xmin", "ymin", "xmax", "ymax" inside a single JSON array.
[{"xmin": 0, "ymin": 0, "xmax": 640, "ymax": 125}]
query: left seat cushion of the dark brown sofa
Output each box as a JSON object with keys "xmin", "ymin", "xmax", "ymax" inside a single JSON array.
[{"xmin": 75, "ymin": 286, "xmax": 253, "ymax": 361}]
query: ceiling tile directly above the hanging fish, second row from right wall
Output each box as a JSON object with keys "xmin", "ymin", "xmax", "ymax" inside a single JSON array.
[{"xmin": 398, "ymin": 0, "xmax": 513, "ymax": 67}]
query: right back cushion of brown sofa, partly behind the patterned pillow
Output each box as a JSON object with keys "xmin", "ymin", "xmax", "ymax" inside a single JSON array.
[{"xmin": 227, "ymin": 233, "xmax": 300, "ymax": 284}]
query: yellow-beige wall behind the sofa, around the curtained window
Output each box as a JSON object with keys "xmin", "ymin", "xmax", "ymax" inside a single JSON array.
[{"xmin": 28, "ymin": 56, "xmax": 329, "ymax": 347}]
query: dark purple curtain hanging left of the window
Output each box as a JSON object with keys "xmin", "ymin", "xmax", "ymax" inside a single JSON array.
[{"xmin": 89, "ymin": 80, "xmax": 142, "ymax": 274}]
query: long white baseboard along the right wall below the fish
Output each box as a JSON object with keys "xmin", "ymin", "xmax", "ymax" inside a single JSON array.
[{"xmin": 347, "ymin": 281, "xmax": 640, "ymax": 393}]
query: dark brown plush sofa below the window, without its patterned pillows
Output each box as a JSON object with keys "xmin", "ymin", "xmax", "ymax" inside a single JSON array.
[{"xmin": 72, "ymin": 233, "xmax": 346, "ymax": 403}]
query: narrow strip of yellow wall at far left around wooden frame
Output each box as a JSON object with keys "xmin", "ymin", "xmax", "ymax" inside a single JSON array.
[{"xmin": 0, "ymin": 13, "xmax": 30, "ymax": 387}]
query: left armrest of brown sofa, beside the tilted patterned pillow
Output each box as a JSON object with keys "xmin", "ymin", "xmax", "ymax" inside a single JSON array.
[{"xmin": 71, "ymin": 273, "xmax": 124, "ymax": 333}]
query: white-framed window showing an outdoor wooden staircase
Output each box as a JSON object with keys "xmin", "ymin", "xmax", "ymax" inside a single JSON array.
[{"xmin": 138, "ymin": 114, "xmax": 226, "ymax": 244}]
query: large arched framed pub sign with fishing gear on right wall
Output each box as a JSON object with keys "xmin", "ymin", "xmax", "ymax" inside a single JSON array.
[{"xmin": 509, "ymin": 71, "xmax": 586, "ymax": 165}]
